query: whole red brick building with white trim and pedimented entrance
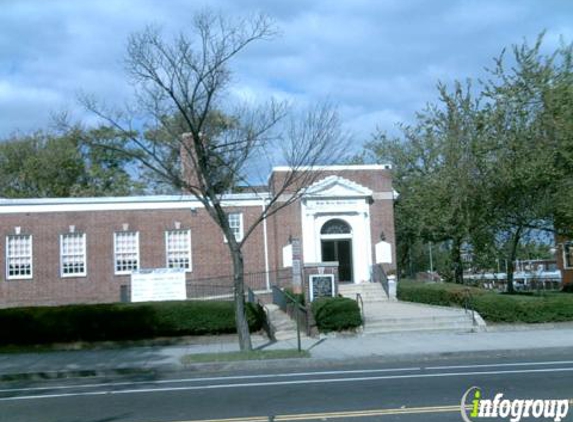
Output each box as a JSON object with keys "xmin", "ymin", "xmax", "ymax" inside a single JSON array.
[{"xmin": 0, "ymin": 165, "xmax": 395, "ymax": 307}]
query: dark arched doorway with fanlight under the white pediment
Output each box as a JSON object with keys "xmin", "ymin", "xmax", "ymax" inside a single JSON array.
[{"xmin": 320, "ymin": 218, "xmax": 353, "ymax": 282}]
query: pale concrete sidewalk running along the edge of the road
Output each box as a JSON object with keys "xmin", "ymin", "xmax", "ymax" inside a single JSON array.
[{"xmin": 0, "ymin": 324, "xmax": 573, "ymax": 381}]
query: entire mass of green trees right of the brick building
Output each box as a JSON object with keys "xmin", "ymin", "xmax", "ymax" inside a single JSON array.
[{"xmin": 362, "ymin": 35, "xmax": 573, "ymax": 289}]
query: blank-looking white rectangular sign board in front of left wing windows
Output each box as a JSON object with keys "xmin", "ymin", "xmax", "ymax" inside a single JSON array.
[{"xmin": 131, "ymin": 268, "xmax": 187, "ymax": 302}]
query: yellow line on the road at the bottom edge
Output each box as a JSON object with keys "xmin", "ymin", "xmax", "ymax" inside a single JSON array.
[{"xmin": 160, "ymin": 404, "xmax": 470, "ymax": 422}]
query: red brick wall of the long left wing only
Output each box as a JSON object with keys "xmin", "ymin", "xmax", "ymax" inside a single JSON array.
[{"xmin": 0, "ymin": 207, "xmax": 265, "ymax": 307}]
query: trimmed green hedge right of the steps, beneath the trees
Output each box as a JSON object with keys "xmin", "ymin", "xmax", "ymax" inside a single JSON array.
[{"xmin": 398, "ymin": 281, "xmax": 573, "ymax": 323}]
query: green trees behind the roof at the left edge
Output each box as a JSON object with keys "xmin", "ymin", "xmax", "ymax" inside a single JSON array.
[{"xmin": 0, "ymin": 127, "xmax": 143, "ymax": 198}]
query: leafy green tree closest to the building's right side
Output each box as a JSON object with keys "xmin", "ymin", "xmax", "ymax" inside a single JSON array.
[{"xmin": 360, "ymin": 83, "xmax": 483, "ymax": 283}]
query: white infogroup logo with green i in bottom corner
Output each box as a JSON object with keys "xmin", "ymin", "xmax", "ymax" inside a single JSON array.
[{"xmin": 461, "ymin": 387, "xmax": 570, "ymax": 422}]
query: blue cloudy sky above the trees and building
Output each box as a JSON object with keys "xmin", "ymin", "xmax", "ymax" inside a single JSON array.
[{"xmin": 0, "ymin": 0, "xmax": 573, "ymax": 144}]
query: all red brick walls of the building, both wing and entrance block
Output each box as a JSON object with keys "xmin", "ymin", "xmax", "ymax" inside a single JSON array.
[{"xmin": 0, "ymin": 165, "xmax": 395, "ymax": 307}]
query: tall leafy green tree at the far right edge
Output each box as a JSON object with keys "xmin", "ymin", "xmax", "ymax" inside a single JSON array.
[{"xmin": 484, "ymin": 35, "xmax": 573, "ymax": 292}]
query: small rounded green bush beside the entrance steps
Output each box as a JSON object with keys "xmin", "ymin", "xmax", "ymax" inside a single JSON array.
[{"xmin": 312, "ymin": 297, "xmax": 362, "ymax": 332}]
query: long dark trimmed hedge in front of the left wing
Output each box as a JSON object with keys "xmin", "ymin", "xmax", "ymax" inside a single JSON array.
[{"xmin": 0, "ymin": 301, "xmax": 265, "ymax": 345}]
